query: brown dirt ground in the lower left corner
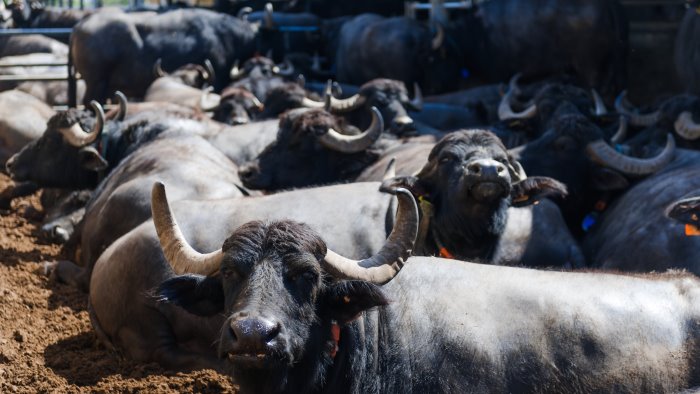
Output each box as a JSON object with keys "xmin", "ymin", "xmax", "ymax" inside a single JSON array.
[{"xmin": 0, "ymin": 174, "xmax": 235, "ymax": 393}]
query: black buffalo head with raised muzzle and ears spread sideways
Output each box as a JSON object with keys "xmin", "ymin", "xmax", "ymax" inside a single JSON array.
[{"xmin": 382, "ymin": 130, "xmax": 566, "ymax": 259}]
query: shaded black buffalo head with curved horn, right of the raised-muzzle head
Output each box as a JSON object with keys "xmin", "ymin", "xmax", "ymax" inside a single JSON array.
[{"xmin": 515, "ymin": 104, "xmax": 675, "ymax": 235}]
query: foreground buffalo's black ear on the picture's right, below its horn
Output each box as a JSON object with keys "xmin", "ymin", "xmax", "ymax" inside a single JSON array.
[{"xmin": 324, "ymin": 280, "xmax": 388, "ymax": 324}]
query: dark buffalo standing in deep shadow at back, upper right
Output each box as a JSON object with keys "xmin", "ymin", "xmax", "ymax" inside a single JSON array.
[{"xmin": 454, "ymin": 0, "xmax": 627, "ymax": 97}]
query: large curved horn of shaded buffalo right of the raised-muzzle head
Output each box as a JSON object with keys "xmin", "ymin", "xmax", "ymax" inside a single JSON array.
[{"xmin": 586, "ymin": 134, "xmax": 676, "ymax": 175}]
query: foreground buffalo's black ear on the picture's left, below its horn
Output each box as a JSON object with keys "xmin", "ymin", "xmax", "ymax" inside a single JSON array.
[{"xmin": 156, "ymin": 275, "xmax": 224, "ymax": 316}]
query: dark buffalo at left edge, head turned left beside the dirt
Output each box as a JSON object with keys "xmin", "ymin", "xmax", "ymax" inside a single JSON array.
[{"xmin": 6, "ymin": 95, "xmax": 210, "ymax": 188}]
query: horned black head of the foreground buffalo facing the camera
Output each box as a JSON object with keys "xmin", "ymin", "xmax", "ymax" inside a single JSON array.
[{"xmin": 152, "ymin": 184, "xmax": 418, "ymax": 392}]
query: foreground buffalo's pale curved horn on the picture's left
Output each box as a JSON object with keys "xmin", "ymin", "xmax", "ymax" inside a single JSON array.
[{"xmin": 151, "ymin": 182, "xmax": 223, "ymax": 275}]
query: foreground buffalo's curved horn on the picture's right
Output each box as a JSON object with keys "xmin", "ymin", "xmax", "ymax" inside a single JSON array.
[{"xmin": 323, "ymin": 188, "xmax": 418, "ymax": 284}]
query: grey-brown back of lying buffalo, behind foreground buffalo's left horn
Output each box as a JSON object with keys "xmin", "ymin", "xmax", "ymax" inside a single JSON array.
[{"xmin": 56, "ymin": 132, "xmax": 249, "ymax": 291}]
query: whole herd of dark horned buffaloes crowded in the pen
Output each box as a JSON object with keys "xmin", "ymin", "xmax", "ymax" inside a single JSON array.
[{"xmin": 0, "ymin": 0, "xmax": 700, "ymax": 393}]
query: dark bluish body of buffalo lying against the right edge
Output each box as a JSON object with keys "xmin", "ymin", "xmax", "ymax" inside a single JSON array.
[{"xmin": 585, "ymin": 149, "xmax": 700, "ymax": 274}]
